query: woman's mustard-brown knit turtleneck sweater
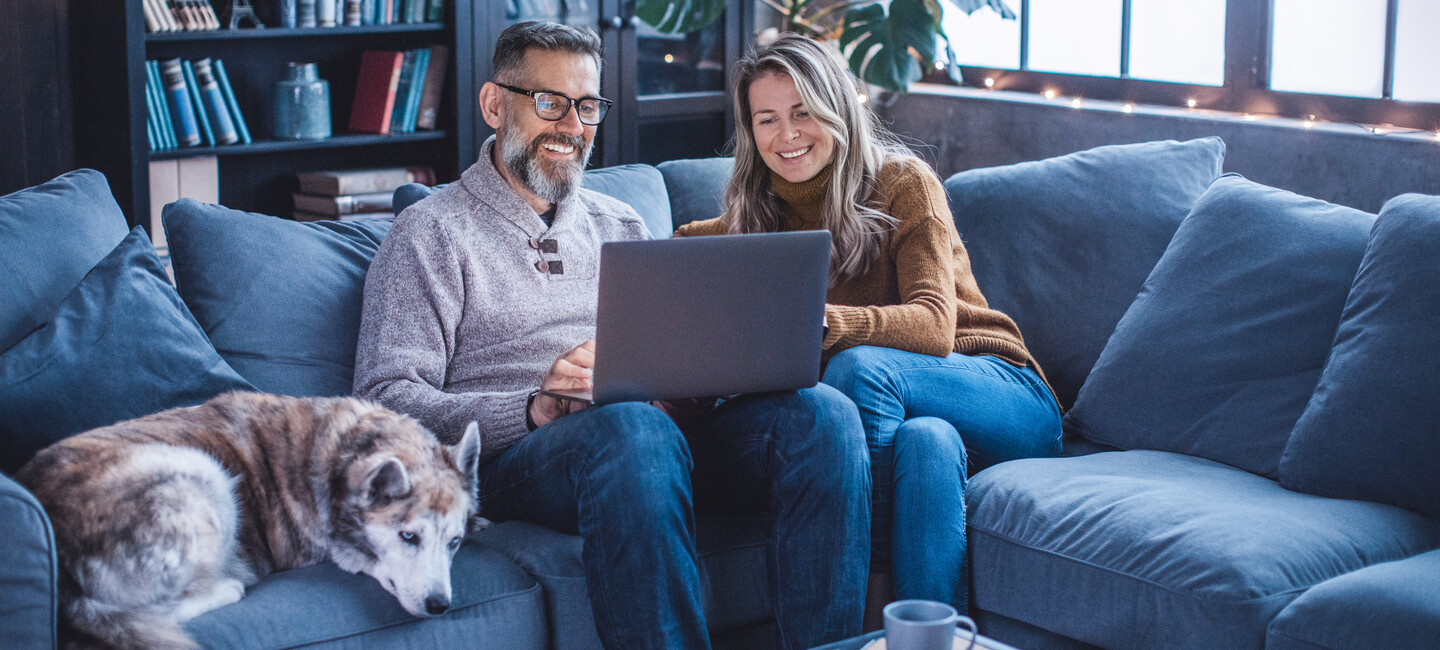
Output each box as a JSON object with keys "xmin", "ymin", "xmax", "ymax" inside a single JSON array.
[{"xmin": 675, "ymin": 159, "xmax": 1044, "ymax": 397}]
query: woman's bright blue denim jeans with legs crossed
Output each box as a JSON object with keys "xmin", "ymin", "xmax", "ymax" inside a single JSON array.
[{"xmin": 825, "ymin": 346, "xmax": 1060, "ymax": 611}]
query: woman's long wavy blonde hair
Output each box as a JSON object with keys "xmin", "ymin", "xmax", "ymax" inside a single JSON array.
[{"xmin": 721, "ymin": 33, "xmax": 913, "ymax": 287}]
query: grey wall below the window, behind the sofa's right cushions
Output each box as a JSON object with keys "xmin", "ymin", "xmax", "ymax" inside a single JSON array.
[{"xmin": 878, "ymin": 85, "xmax": 1440, "ymax": 212}]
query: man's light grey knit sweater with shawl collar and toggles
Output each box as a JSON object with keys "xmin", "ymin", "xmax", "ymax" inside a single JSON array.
[{"xmin": 354, "ymin": 137, "xmax": 649, "ymax": 460}]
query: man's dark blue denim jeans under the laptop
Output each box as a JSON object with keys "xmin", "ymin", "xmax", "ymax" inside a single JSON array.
[{"xmin": 480, "ymin": 385, "xmax": 870, "ymax": 649}]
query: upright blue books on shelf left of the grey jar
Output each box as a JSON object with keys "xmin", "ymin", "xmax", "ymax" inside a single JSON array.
[{"xmin": 145, "ymin": 58, "xmax": 251, "ymax": 151}]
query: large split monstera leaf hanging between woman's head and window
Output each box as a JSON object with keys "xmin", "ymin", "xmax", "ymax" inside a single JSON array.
[{"xmin": 840, "ymin": 0, "xmax": 940, "ymax": 92}]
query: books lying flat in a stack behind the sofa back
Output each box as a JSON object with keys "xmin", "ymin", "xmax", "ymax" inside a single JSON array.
[{"xmin": 295, "ymin": 166, "xmax": 435, "ymax": 221}]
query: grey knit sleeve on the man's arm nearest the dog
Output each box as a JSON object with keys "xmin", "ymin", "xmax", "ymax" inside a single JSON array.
[{"xmin": 354, "ymin": 219, "xmax": 528, "ymax": 458}]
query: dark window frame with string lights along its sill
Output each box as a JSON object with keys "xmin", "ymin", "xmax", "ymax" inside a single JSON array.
[{"xmin": 926, "ymin": 0, "xmax": 1440, "ymax": 131}]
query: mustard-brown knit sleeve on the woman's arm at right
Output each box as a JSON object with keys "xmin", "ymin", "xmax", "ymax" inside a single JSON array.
[{"xmin": 822, "ymin": 163, "xmax": 958, "ymax": 356}]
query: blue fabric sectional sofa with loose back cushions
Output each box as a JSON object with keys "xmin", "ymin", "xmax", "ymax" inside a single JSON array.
[{"xmin": 0, "ymin": 138, "xmax": 1440, "ymax": 649}]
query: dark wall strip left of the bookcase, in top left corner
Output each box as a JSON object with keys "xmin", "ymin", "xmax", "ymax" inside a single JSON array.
[{"xmin": 0, "ymin": 0, "xmax": 75, "ymax": 195}]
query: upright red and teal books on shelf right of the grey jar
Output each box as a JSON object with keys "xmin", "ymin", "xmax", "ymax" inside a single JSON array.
[{"xmin": 350, "ymin": 45, "xmax": 449, "ymax": 134}]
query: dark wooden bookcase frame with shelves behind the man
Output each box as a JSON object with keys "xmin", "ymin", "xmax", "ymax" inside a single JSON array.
[{"xmin": 71, "ymin": 0, "xmax": 488, "ymax": 228}]
